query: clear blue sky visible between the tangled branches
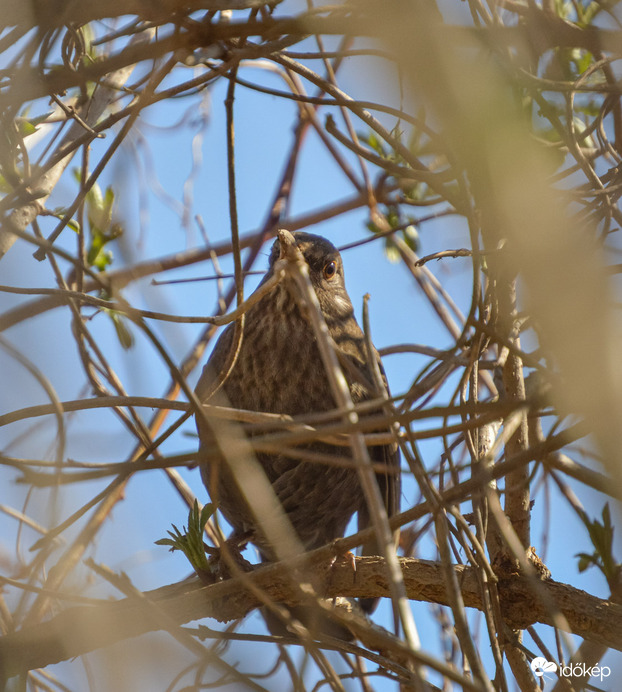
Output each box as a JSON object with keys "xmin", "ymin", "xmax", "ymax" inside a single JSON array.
[{"xmin": 0, "ymin": 2, "xmax": 622, "ymax": 690}]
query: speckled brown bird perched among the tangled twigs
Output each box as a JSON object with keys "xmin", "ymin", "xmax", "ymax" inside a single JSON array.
[{"xmin": 195, "ymin": 230, "xmax": 400, "ymax": 632}]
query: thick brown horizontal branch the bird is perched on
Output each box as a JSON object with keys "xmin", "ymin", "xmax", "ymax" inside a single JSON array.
[{"xmin": 0, "ymin": 549, "xmax": 622, "ymax": 677}]
